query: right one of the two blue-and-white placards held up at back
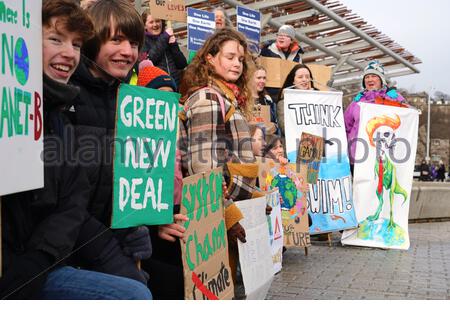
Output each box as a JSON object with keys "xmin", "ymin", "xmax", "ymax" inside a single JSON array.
[{"xmin": 236, "ymin": 6, "xmax": 261, "ymax": 53}]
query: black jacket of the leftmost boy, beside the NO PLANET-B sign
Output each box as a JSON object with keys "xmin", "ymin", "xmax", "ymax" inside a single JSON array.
[{"xmin": 0, "ymin": 77, "xmax": 89, "ymax": 299}]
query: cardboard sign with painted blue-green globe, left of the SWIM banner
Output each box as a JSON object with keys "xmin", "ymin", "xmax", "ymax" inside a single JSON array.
[{"xmin": 259, "ymin": 158, "xmax": 311, "ymax": 248}]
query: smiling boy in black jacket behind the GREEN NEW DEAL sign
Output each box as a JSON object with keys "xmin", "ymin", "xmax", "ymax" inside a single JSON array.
[{"xmin": 67, "ymin": 0, "xmax": 155, "ymax": 290}]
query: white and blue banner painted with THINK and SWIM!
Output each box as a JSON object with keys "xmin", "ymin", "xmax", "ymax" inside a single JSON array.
[{"xmin": 284, "ymin": 89, "xmax": 358, "ymax": 234}]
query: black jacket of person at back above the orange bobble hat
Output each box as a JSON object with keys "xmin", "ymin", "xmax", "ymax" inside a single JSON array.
[{"xmin": 143, "ymin": 32, "xmax": 187, "ymax": 87}]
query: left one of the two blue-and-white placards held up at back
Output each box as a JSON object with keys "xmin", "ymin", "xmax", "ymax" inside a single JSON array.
[{"xmin": 187, "ymin": 8, "xmax": 216, "ymax": 51}]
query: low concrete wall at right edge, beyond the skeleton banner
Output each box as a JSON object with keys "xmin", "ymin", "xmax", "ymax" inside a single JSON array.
[{"xmin": 409, "ymin": 181, "xmax": 450, "ymax": 219}]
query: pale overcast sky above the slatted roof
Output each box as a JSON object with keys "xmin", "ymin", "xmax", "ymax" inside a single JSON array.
[{"xmin": 340, "ymin": 0, "xmax": 450, "ymax": 94}]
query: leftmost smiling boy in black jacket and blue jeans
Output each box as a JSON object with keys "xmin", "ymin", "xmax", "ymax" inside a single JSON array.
[{"xmin": 0, "ymin": 0, "xmax": 151, "ymax": 299}]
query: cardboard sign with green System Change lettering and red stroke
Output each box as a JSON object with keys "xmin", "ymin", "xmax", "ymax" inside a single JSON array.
[{"xmin": 180, "ymin": 168, "xmax": 234, "ymax": 300}]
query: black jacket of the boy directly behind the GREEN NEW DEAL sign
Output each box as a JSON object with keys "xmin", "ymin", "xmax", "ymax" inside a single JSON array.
[{"xmin": 67, "ymin": 61, "xmax": 119, "ymax": 226}]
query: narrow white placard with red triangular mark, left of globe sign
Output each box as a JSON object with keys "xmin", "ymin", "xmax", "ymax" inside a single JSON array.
[{"xmin": 266, "ymin": 189, "xmax": 284, "ymax": 273}]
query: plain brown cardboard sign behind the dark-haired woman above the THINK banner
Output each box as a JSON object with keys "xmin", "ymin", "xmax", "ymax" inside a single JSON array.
[{"xmin": 258, "ymin": 57, "xmax": 332, "ymax": 91}]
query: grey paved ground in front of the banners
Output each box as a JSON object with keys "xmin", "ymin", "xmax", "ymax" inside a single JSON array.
[{"xmin": 267, "ymin": 222, "xmax": 450, "ymax": 300}]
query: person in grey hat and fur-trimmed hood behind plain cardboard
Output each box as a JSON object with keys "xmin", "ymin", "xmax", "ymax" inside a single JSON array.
[{"xmin": 261, "ymin": 24, "xmax": 304, "ymax": 63}]
